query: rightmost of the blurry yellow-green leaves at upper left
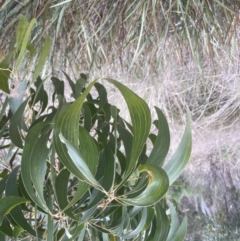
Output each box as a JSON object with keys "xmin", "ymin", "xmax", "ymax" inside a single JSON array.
[{"xmin": 33, "ymin": 35, "xmax": 52, "ymax": 81}]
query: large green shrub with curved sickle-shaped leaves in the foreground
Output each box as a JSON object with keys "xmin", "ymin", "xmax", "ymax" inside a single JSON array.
[{"xmin": 0, "ymin": 74, "xmax": 191, "ymax": 241}]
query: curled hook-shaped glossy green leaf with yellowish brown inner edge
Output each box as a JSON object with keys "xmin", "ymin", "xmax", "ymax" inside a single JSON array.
[{"xmin": 119, "ymin": 164, "xmax": 169, "ymax": 206}]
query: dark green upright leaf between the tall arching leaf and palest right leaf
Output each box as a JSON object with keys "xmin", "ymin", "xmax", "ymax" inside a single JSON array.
[{"xmin": 147, "ymin": 107, "xmax": 170, "ymax": 166}]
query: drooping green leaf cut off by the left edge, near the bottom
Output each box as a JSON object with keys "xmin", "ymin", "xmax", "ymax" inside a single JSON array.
[{"xmin": 0, "ymin": 196, "xmax": 29, "ymax": 225}]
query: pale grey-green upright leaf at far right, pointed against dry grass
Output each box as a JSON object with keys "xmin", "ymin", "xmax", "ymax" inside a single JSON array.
[{"xmin": 163, "ymin": 114, "xmax": 192, "ymax": 185}]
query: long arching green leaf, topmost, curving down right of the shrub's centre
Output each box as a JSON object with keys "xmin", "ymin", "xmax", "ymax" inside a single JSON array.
[{"xmin": 106, "ymin": 79, "xmax": 151, "ymax": 186}]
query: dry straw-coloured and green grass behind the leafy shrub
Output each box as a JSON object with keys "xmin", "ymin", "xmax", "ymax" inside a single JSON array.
[{"xmin": 0, "ymin": 0, "xmax": 240, "ymax": 240}]
